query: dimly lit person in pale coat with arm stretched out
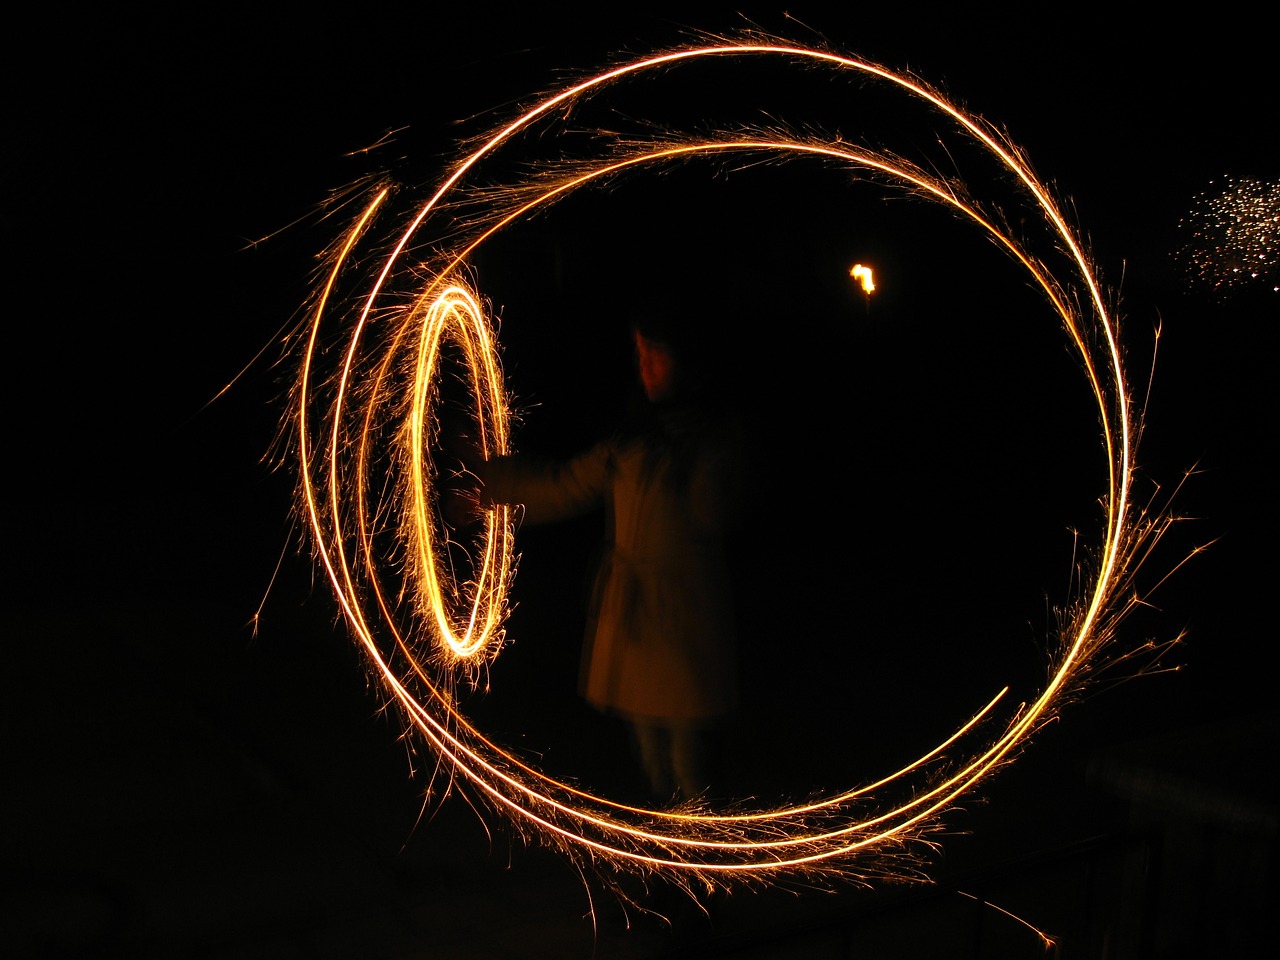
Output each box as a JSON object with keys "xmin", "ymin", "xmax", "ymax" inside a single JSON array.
[{"xmin": 474, "ymin": 319, "xmax": 740, "ymax": 801}]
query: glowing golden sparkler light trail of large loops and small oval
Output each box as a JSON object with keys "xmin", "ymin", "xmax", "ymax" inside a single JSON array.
[{"xmin": 291, "ymin": 36, "xmax": 1167, "ymax": 891}]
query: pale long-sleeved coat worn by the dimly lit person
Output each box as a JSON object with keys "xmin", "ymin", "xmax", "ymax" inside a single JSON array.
[{"xmin": 480, "ymin": 408, "xmax": 740, "ymax": 727}]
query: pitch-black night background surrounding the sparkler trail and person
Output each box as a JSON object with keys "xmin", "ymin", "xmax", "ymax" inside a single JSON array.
[{"xmin": 0, "ymin": 4, "xmax": 1280, "ymax": 957}]
